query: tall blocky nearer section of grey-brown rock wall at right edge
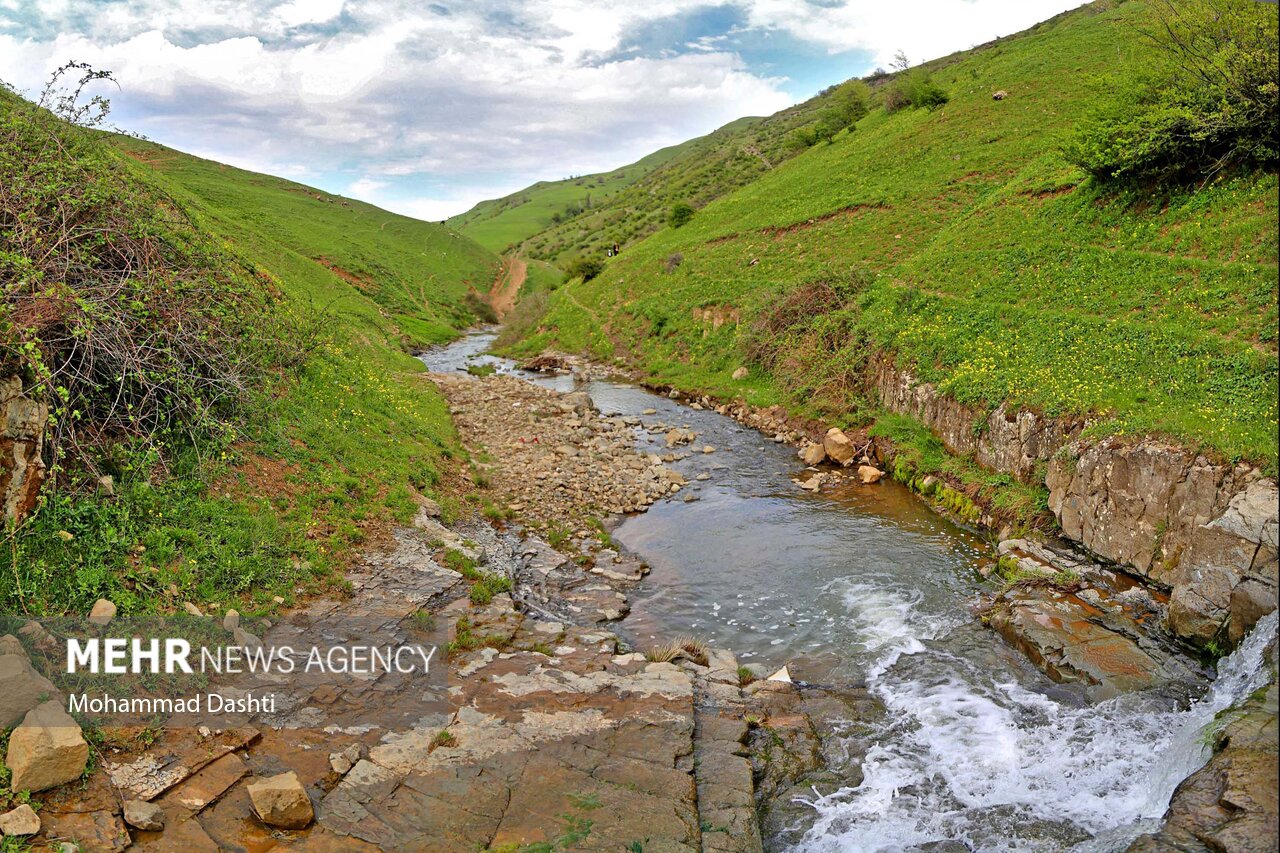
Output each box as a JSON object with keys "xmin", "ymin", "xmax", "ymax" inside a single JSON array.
[{"xmin": 1046, "ymin": 438, "xmax": 1280, "ymax": 644}]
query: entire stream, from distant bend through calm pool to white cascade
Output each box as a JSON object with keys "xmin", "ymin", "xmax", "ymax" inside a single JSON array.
[{"xmin": 421, "ymin": 333, "xmax": 1276, "ymax": 853}]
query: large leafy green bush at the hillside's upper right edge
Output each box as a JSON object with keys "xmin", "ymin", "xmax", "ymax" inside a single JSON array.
[{"xmin": 1064, "ymin": 0, "xmax": 1280, "ymax": 183}]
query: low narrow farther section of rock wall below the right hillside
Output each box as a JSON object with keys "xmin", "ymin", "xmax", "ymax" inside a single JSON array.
[{"xmin": 870, "ymin": 359, "xmax": 1085, "ymax": 483}]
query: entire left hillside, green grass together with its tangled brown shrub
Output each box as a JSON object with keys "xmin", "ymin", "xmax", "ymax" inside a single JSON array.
[{"xmin": 0, "ymin": 90, "xmax": 499, "ymax": 613}]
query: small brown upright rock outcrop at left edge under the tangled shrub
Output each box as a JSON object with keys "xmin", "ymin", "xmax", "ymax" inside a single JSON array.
[{"xmin": 0, "ymin": 377, "xmax": 49, "ymax": 521}]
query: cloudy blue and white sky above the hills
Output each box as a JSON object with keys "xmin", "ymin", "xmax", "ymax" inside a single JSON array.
[{"xmin": 0, "ymin": 0, "xmax": 1079, "ymax": 219}]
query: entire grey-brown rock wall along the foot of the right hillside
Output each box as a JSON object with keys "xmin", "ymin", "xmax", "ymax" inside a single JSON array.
[{"xmin": 869, "ymin": 359, "xmax": 1280, "ymax": 646}]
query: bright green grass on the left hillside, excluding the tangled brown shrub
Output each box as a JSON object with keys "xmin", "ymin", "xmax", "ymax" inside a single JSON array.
[{"xmin": 0, "ymin": 94, "xmax": 498, "ymax": 615}]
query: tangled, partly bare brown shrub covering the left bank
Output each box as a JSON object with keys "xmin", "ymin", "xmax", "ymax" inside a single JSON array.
[{"xmin": 0, "ymin": 63, "xmax": 294, "ymax": 479}]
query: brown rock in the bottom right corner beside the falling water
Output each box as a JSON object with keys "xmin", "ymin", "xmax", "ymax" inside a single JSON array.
[{"xmin": 1129, "ymin": 681, "xmax": 1280, "ymax": 853}]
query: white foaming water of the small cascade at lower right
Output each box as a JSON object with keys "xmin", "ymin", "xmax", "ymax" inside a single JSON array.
[{"xmin": 799, "ymin": 604, "xmax": 1276, "ymax": 852}]
